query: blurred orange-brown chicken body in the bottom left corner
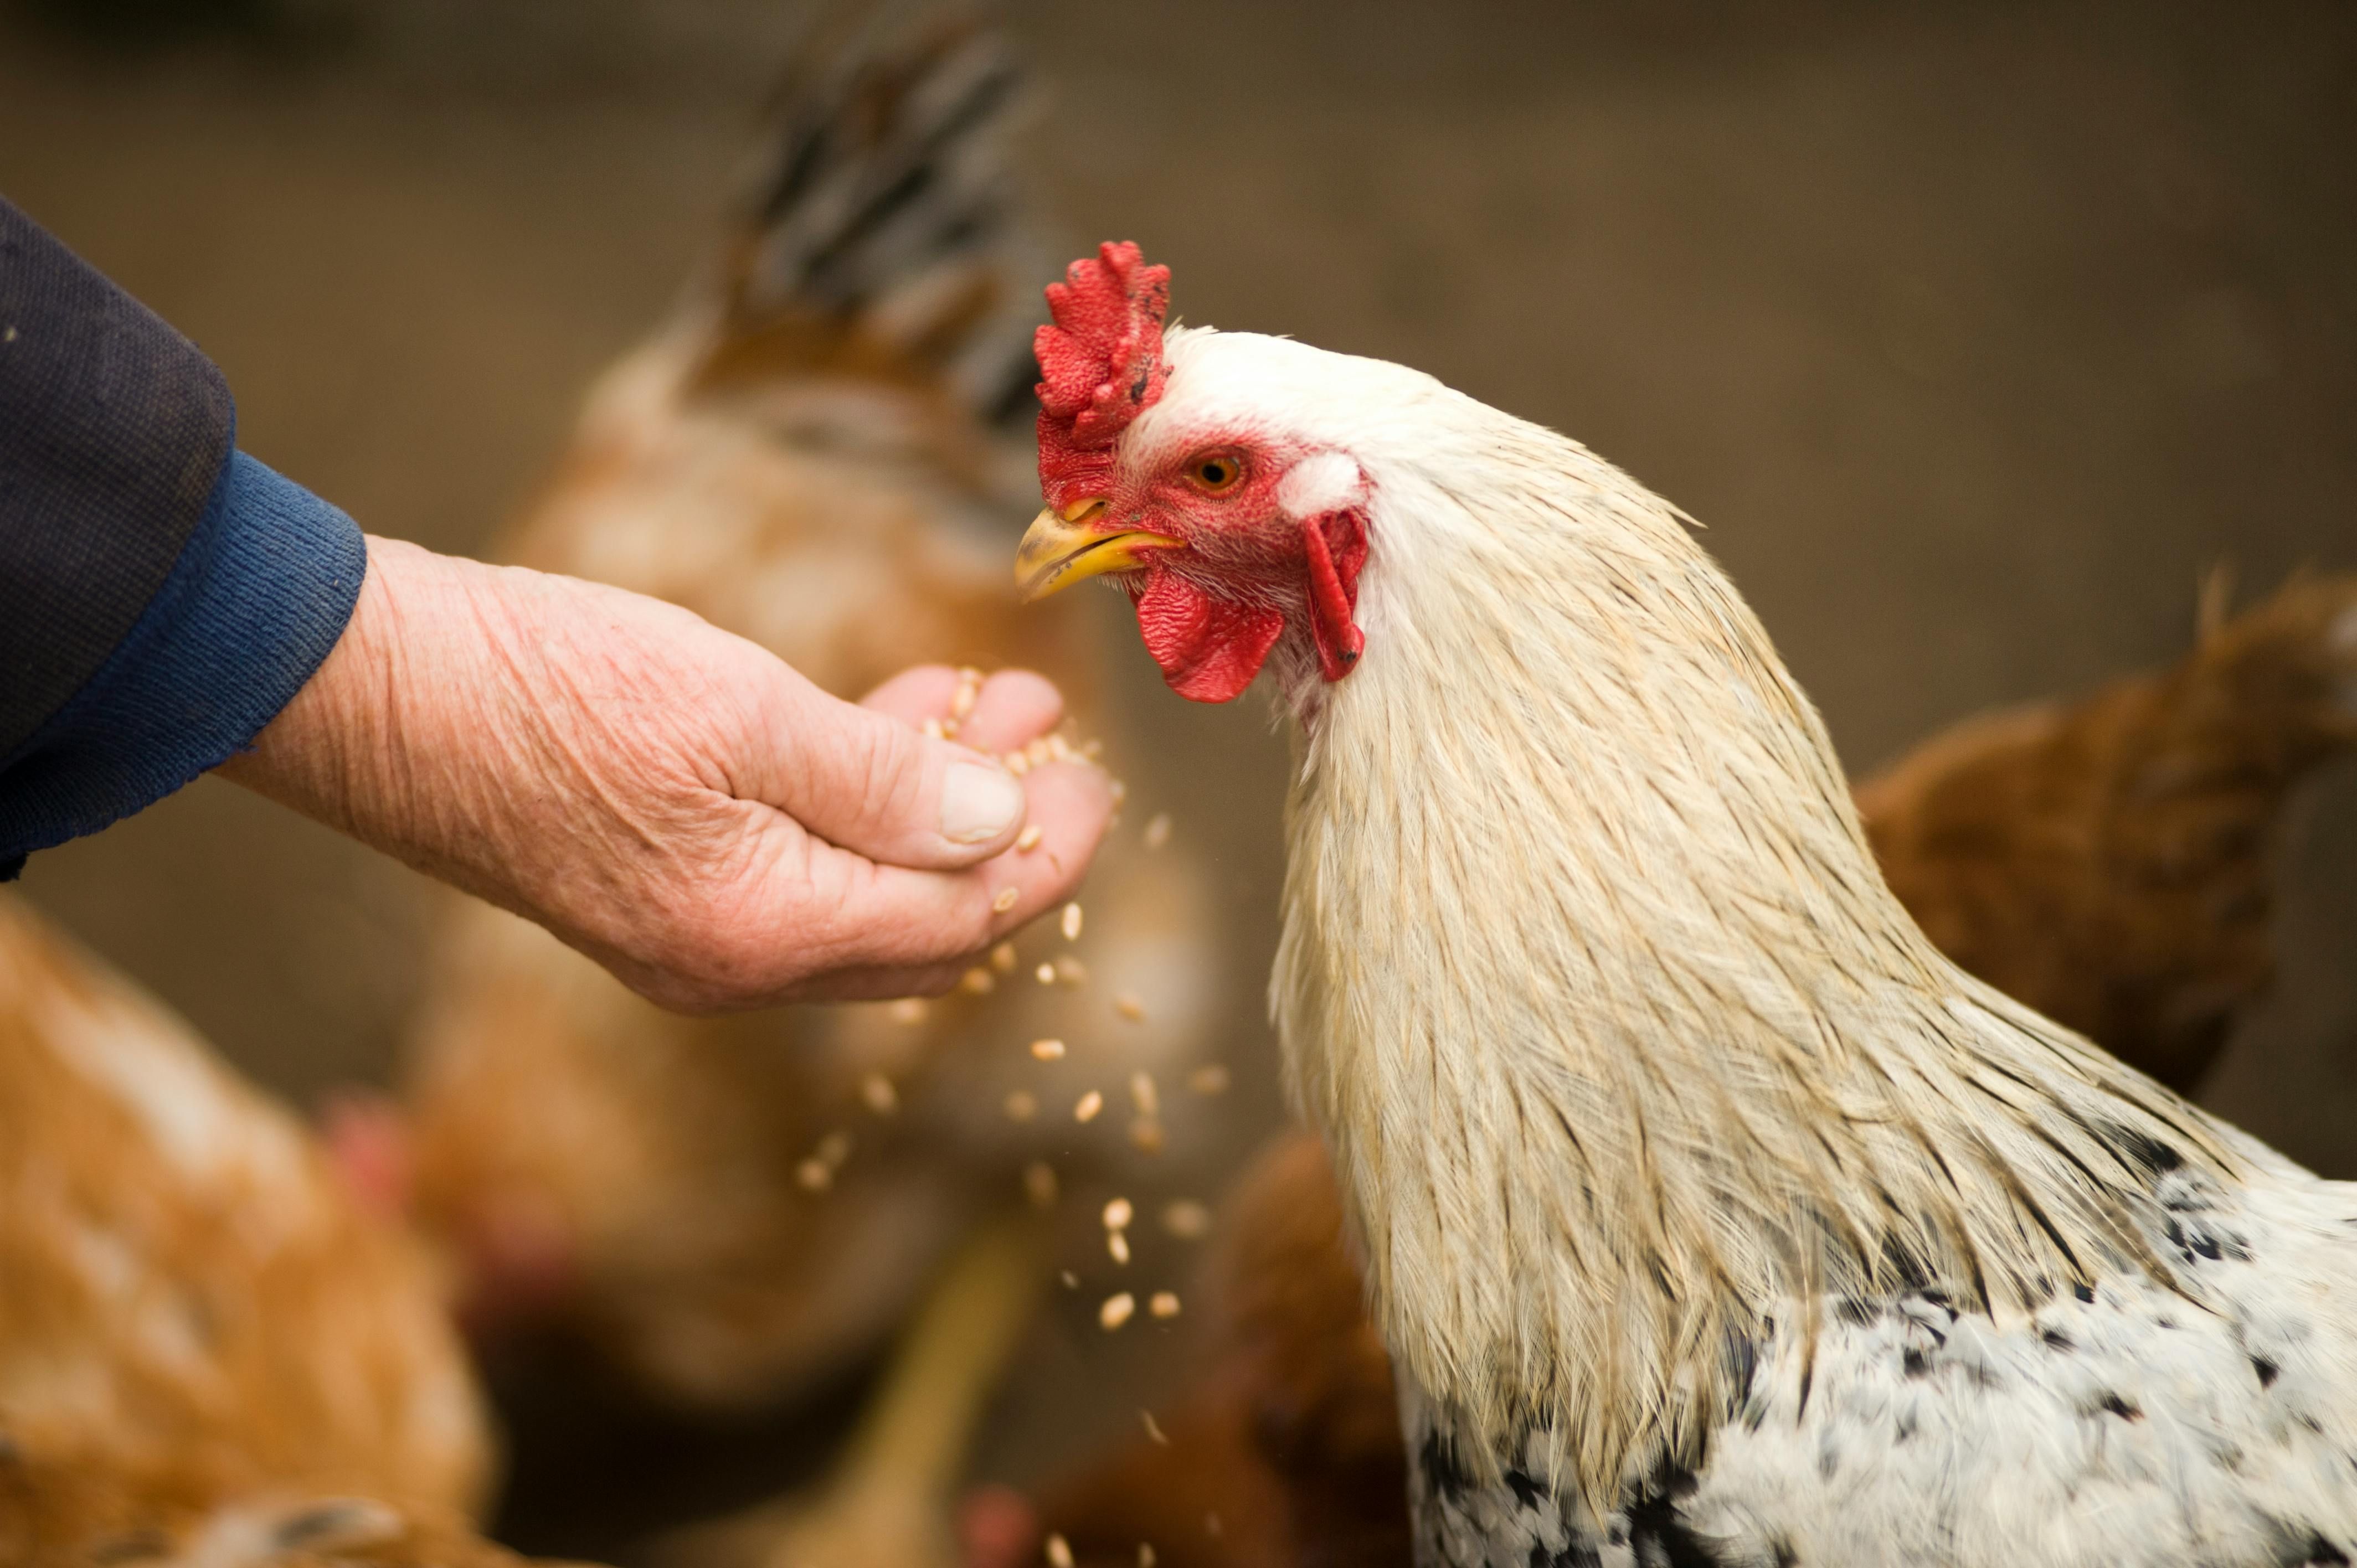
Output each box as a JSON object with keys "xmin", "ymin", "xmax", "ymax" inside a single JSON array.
[{"xmin": 0, "ymin": 899, "xmax": 551, "ymax": 1568}]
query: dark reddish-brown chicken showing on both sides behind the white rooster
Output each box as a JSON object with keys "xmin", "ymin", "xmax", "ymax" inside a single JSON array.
[{"xmin": 1027, "ymin": 577, "xmax": 2357, "ymax": 1568}]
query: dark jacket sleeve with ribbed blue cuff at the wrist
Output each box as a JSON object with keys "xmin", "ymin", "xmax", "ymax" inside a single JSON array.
[{"xmin": 0, "ymin": 203, "xmax": 368, "ymax": 882}]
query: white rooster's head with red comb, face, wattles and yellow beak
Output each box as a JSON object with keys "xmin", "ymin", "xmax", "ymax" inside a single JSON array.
[{"xmin": 1016, "ymin": 243, "xmax": 1367, "ymax": 703}]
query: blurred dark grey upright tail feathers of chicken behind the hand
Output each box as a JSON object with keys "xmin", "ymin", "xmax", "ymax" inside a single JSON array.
[{"xmin": 700, "ymin": 12, "xmax": 1044, "ymax": 420}]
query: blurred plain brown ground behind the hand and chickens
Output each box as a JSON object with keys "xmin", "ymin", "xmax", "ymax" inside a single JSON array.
[{"xmin": 0, "ymin": 0, "xmax": 2357, "ymax": 1554}]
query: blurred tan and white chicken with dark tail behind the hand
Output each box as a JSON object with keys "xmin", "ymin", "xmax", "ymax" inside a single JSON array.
[{"xmin": 386, "ymin": 24, "xmax": 1223, "ymax": 1412}]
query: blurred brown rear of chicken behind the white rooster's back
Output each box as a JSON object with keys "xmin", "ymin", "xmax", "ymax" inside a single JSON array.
[{"xmin": 1857, "ymin": 575, "xmax": 2357, "ymax": 1087}]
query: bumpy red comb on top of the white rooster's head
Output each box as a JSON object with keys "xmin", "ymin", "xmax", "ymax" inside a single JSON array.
[{"xmin": 1032, "ymin": 240, "xmax": 1171, "ymax": 512}]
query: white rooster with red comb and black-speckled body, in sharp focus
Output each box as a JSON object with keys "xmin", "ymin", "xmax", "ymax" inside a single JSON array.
[{"xmin": 1018, "ymin": 245, "xmax": 2357, "ymax": 1568}]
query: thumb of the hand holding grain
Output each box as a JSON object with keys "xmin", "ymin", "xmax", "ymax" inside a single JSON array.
[{"xmin": 747, "ymin": 672, "xmax": 1025, "ymax": 870}]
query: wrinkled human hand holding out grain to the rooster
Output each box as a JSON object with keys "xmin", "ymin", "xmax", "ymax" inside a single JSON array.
[{"xmin": 219, "ymin": 538, "xmax": 1113, "ymax": 1012}]
